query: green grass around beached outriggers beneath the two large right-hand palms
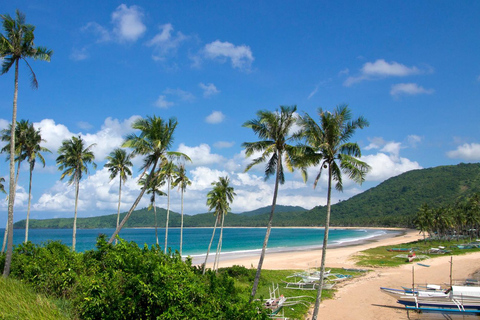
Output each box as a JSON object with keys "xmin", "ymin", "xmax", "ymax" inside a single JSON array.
[{"xmin": 220, "ymin": 266, "xmax": 364, "ymax": 319}]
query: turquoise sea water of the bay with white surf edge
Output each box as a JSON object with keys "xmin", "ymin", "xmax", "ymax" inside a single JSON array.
[{"xmin": 0, "ymin": 228, "xmax": 398, "ymax": 257}]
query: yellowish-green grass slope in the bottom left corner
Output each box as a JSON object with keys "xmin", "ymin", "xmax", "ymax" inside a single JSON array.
[{"xmin": 0, "ymin": 277, "xmax": 72, "ymax": 320}]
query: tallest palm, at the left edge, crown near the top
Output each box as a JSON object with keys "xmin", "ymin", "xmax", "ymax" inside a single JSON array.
[{"xmin": 0, "ymin": 10, "xmax": 53, "ymax": 277}]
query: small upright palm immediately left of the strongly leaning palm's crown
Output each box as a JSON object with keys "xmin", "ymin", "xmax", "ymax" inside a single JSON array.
[{"xmin": 105, "ymin": 148, "xmax": 133, "ymax": 242}]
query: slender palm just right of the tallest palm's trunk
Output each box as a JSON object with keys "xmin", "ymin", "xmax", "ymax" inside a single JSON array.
[{"xmin": 24, "ymin": 123, "xmax": 51, "ymax": 242}]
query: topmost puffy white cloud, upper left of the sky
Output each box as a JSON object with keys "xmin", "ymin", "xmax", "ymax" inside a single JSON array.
[{"xmin": 112, "ymin": 4, "xmax": 147, "ymax": 42}]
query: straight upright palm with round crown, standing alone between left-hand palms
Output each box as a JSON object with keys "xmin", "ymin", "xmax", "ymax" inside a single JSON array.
[{"xmin": 57, "ymin": 136, "xmax": 97, "ymax": 251}]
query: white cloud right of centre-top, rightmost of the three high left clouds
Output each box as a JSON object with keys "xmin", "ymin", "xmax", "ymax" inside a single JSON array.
[{"xmin": 204, "ymin": 40, "xmax": 254, "ymax": 70}]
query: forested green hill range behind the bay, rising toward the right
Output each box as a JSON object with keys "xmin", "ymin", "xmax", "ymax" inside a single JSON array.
[{"xmin": 14, "ymin": 163, "xmax": 480, "ymax": 228}]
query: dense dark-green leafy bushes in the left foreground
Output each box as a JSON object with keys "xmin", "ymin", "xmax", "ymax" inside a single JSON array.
[{"xmin": 0, "ymin": 236, "xmax": 266, "ymax": 319}]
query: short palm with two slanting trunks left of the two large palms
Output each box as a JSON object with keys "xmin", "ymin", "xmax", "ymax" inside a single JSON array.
[{"xmin": 203, "ymin": 177, "xmax": 236, "ymax": 274}]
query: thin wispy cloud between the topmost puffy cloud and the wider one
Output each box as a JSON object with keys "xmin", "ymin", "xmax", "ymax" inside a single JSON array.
[{"xmin": 147, "ymin": 23, "xmax": 187, "ymax": 61}]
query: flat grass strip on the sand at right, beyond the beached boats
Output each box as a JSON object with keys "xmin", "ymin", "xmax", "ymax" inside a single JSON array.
[{"xmin": 354, "ymin": 240, "xmax": 480, "ymax": 267}]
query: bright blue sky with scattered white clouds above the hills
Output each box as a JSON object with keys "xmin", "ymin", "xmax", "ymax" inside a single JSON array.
[{"xmin": 0, "ymin": 0, "xmax": 480, "ymax": 226}]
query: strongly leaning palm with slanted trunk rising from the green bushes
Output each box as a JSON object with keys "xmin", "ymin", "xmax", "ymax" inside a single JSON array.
[{"xmin": 108, "ymin": 116, "xmax": 190, "ymax": 243}]
